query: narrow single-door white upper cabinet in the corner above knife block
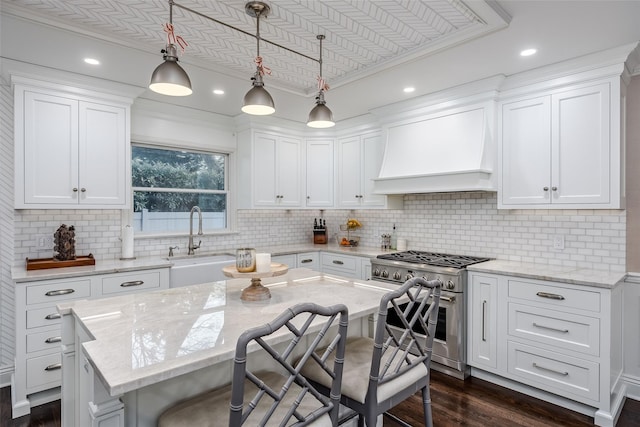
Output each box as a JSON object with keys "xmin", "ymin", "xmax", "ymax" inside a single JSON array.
[{"xmin": 305, "ymin": 139, "xmax": 334, "ymax": 208}]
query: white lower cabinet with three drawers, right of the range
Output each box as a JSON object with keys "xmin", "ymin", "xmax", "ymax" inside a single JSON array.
[{"xmin": 467, "ymin": 271, "xmax": 624, "ymax": 427}]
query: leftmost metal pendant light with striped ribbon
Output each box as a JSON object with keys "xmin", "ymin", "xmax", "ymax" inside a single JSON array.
[{"xmin": 149, "ymin": 1, "xmax": 193, "ymax": 96}]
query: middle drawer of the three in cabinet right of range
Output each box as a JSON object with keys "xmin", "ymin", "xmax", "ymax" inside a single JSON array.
[{"xmin": 509, "ymin": 303, "xmax": 600, "ymax": 356}]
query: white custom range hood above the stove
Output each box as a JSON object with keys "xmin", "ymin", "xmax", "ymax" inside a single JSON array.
[{"xmin": 373, "ymin": 81, "xmax": 497, "ymax": 194}]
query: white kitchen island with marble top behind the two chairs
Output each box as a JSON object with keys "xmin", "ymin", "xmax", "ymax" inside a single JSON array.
[{"xmin": 58, "ymin": 268, "xmax": 396, "ymax": 427}]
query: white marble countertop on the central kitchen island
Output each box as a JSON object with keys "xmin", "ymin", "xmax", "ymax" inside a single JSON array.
[{"xmin": 58, "ymin": 268, "xmax": 397, "ymax": 396}]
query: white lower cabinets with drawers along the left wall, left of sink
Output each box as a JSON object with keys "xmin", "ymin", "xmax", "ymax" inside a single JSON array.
[{"xmin": 11, "ymin": 268, "xmax": 169, "ymax": 418}]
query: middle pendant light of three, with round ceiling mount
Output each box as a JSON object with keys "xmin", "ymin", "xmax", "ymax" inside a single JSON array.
[{"xmin": 242, "ymin": 1, "xmax": 276, "ymax": 116}]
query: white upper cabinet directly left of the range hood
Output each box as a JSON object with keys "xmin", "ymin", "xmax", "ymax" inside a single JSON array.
[{"xmin": 337, "ymin": 132, "xmax": 402, "ymax": 209}]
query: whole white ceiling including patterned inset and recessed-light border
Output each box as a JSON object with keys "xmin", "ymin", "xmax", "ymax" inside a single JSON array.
[{"xmin": 0, "ymin": 0, "xmax": 640, "ymax": 122}]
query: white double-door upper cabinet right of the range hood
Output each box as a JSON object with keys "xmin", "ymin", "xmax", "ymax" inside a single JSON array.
[{"xmin": 498, "ymin": 79, "xmax": 624, "ymax": 209}]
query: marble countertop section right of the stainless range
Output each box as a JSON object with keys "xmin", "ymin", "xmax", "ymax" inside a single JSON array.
[{"xmin": 467, "ymin": 260, "xmax": 626, "ymax": 288}]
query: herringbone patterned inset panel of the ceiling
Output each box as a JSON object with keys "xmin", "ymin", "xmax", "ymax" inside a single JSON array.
[{"xmin": 3, "ymin": 0, "xmax": 506, "ymax": 94}]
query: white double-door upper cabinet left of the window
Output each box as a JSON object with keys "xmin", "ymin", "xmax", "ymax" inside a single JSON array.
[{"xmin": 15, "ymin": 80, "xmax": 131, "ymax": 209}]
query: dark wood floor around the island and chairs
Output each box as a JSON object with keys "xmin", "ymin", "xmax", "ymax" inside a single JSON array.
[{"xmin": 0, "ymin": 371, "xmax": 640, "ymax": 427}]
